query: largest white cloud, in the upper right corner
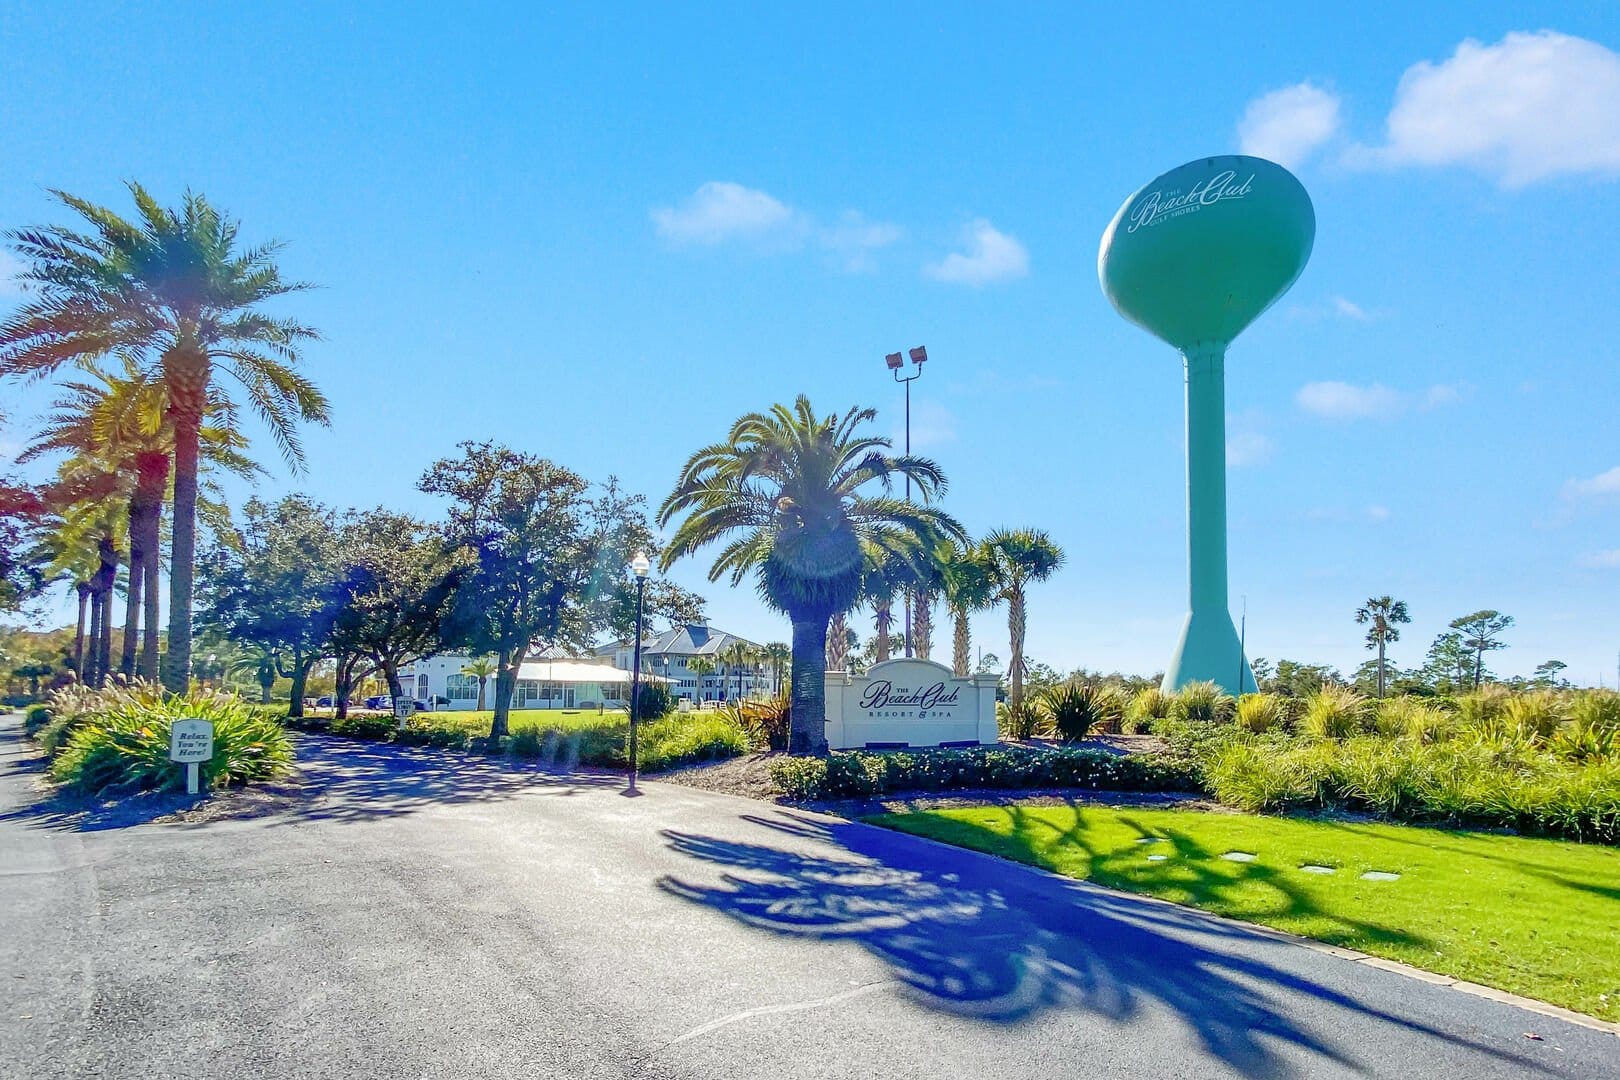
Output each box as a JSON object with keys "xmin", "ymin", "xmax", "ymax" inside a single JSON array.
[{"xmin": 1349, "ymin": 31, "xmax": 1620, "ymax": 188}]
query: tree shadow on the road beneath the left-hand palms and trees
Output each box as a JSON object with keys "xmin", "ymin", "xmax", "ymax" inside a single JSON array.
[{"xmin": 0, "ymin": 735, "xmax": 625, "ymax": 832}]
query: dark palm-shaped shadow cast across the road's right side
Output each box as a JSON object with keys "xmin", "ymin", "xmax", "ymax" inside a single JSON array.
[{"xmin": 659, "ymin": 810, "xmax": 1568, "ymax": 1077}]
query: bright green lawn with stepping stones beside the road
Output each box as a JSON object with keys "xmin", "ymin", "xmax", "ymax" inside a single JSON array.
[{"xmin": 868, "ymin": 805, "xmax": 1620, "ymax": 1020}]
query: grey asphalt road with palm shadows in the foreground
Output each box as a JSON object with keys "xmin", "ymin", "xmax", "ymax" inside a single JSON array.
[{"xmin": 0, "ymin": 717, "xmax": 1620, "ymax": 1080}]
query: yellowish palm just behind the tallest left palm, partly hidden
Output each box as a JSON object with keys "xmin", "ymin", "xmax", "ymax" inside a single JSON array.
[{"xmin": 18, "ymin": 365, "xmax": 262, "ymax": 680}]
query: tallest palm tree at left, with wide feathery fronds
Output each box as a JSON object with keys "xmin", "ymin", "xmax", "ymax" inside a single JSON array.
[{"xmin": 0, "ymin": 183, "xmax": 327, "ymax": 691}]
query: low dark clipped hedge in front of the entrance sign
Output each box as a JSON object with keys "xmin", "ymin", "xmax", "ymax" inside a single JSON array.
[{"xmin": 771, "ymin": 746, "xmax": 1197, "ymax": 798}]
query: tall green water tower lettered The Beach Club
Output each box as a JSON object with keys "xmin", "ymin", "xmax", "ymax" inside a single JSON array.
[{"xmin": 1097, "ymin": 155, "xmax": 1315, "ymax": 693}]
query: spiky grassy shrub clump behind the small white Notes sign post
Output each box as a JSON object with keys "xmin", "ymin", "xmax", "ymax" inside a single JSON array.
[{"xmin": 50, "ymin": 683, "xmax": 293, "ymax": 793}]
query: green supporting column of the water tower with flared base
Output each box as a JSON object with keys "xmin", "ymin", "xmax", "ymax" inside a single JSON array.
[{"xmin": 1163, "ymin": 345, "xmax": 1256, "ymax": 693}]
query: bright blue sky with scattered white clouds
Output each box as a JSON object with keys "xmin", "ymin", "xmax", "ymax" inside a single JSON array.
[{"xmin": 0, "ymin": 3, "xmax": 1620, "ymax": 685}]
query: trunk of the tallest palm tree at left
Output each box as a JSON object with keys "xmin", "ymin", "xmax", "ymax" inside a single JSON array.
[{"xmin": 164, "ymin": 362, "xmax": 209, "ymax": 693}]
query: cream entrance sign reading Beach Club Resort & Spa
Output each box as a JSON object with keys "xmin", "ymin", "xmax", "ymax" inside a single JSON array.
[{"xmin": 826, "ymin": 659, "xmax": 1001, "ymax": 750}]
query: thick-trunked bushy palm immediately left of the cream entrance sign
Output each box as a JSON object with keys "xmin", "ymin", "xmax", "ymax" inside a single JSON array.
[{"xmin": 658, "ymin": 395, "xmax": 964, "ymax": 755}]
